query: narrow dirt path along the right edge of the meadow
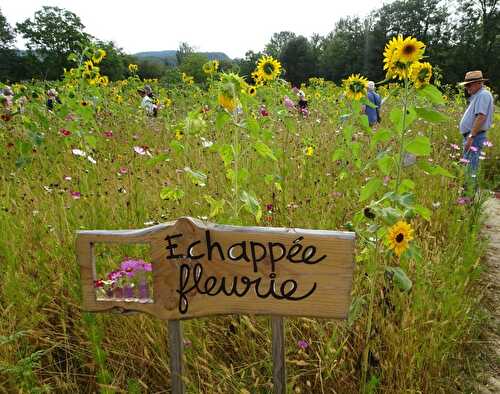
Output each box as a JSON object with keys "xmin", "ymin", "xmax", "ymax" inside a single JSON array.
[{"xmin": 479, "ymin": 198, "xmax": 500, "ymax": 394}]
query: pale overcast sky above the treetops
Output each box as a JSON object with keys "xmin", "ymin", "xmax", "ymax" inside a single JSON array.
[{"xmin": 0, "ymin": 0, "xmax": 389, "ymax": 58}]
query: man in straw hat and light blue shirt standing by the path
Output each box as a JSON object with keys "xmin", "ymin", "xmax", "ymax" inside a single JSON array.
[{"xmin": 460, "ymin": 71, "xmax": 494, "ymax": 182}]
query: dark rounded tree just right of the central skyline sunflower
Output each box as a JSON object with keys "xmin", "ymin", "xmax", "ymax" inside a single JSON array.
[{"xmin": 280, "ymin": 36, "xmax": 317, "ymax": 86}]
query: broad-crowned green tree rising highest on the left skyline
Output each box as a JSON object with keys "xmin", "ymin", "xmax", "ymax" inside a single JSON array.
[{"xmin": 16, "ymin": 6, "xmax": 90, "ymax": 79}]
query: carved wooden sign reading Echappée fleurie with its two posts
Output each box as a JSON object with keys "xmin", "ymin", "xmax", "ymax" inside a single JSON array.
[{"xmin": 76, "ymin": 218, "xmax": 355, "ymax": 393}]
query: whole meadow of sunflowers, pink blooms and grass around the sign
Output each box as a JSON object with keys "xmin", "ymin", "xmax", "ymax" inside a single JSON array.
[{"xmin": 0, "ymin": 37, "xmax": 500, "ymax": 393}]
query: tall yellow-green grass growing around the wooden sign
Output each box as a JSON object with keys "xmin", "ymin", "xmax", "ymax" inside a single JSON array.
[{"xmin": 0, "ymin": 79, "xmax": 500, "ymax": 393}]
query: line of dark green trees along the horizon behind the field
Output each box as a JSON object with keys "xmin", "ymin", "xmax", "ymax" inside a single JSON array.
[{"xmin": 0, "ymin": 0, "xmax": 500, "ymax": 90}]
